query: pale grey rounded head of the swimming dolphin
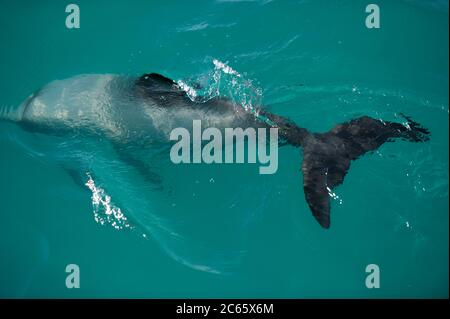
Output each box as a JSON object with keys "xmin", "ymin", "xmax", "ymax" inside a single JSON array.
[{"xmin": 18, "ymin": 75, "xmax": 124, "ymax": 135}]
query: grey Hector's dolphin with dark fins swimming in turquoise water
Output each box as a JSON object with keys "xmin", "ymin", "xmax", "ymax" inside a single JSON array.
[{"xmin": 1, "ymin": 73, "xmax": 430, "ymax": 228}]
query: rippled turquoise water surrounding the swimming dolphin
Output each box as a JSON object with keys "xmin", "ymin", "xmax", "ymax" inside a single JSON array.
[{"xmin": 0, "ymin": 0, "xmax": 449, "ymax": 298}]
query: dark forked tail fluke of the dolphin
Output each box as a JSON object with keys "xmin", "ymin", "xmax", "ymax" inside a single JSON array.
[{"xmin": 302, "ymin": 115, "xmax": 430, "ymax": 228}]
